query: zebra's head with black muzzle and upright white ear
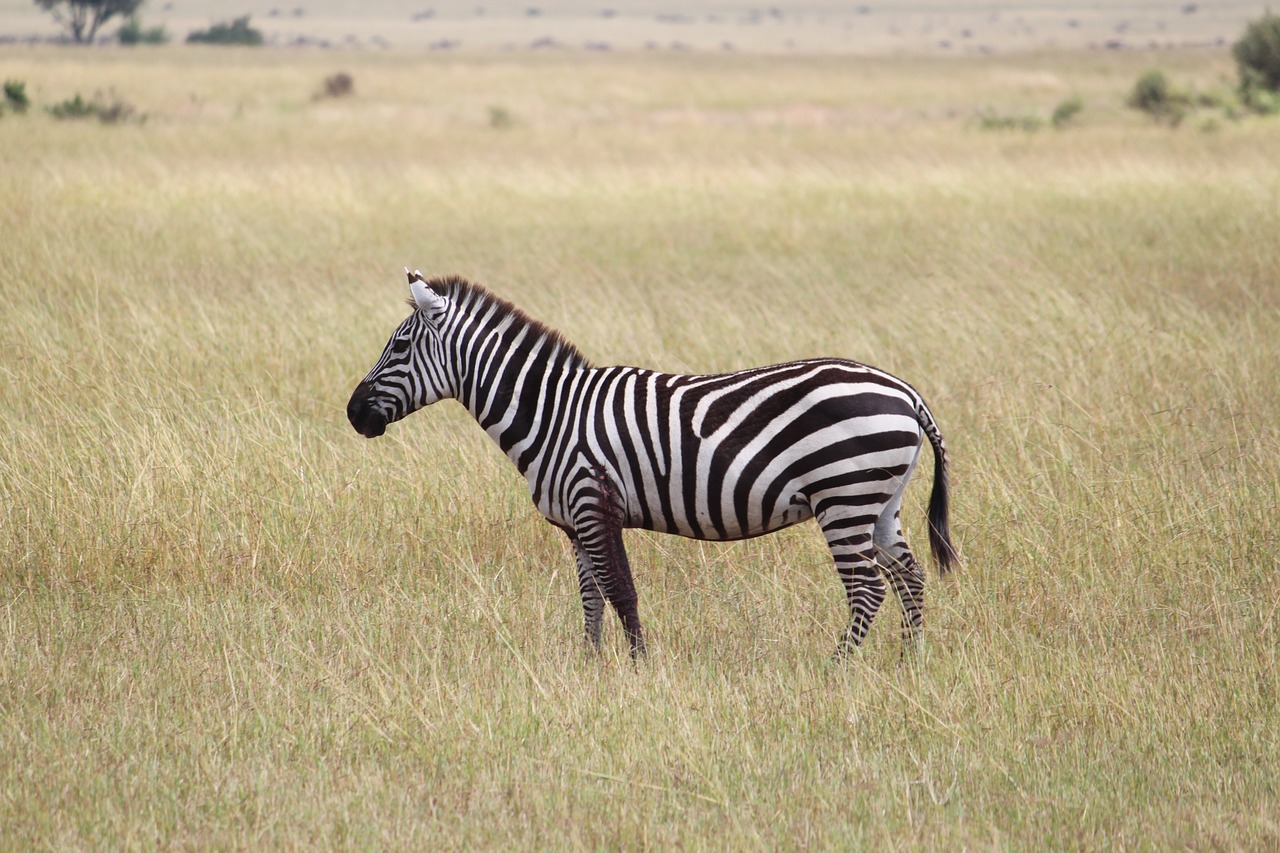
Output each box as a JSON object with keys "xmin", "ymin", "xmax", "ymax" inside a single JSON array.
[{"xmin": 347, "ymin": 268, "xmax": 453, "ymax": 438}]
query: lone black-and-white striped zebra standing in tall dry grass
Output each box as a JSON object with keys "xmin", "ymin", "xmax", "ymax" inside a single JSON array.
[{"xmin": 347, "ymin": 268, "xmax": 957, "ymax": 658}]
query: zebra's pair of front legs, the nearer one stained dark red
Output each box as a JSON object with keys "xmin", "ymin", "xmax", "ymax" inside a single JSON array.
[{"xmin": 566, "ymin": 475, "xmax": 645, "ymax": 658}]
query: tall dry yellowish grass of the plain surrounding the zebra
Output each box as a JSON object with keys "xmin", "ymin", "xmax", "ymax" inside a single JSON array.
[{"xmin": 0, "ymin": 46, "xmax": 1280, "ymax": 849}]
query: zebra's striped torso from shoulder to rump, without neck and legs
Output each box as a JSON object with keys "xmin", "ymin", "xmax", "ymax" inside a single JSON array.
[{"xmin": 504, "ymin": 359, "xmax": 923, "ymax": 539}]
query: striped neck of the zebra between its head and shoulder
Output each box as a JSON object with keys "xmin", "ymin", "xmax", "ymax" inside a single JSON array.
[{"xmin": 458, "ymin": 324, "xmax": 588, "ymax": 473}]
